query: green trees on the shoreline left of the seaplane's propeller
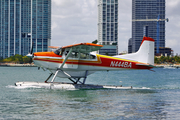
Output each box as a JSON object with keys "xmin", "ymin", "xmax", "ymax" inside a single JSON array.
[{"xmin": 0, "ymin": 54, "xmax": 32, "ymax": 64}]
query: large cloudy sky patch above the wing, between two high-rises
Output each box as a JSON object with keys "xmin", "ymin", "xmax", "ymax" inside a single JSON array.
[{"xmin": 52, "ymin": 0, "xmax": 97, "ymax": 46}]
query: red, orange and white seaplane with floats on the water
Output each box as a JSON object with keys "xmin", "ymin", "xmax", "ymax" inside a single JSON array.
[{"xmin": 15, "ymin": 37, "xmax": 154, "ymax": 89}]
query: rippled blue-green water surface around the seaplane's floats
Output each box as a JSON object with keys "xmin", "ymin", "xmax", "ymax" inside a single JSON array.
[{"xmin": 0, "ymin": 67, "xmax": 180, "ymax": 120}]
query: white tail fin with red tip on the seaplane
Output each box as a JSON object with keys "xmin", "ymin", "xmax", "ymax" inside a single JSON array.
[{"xmin": 114, "ymin": 37, "xmax": 154, "ymax": 65}]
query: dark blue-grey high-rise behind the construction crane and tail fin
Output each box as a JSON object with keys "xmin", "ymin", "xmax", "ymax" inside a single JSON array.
[{"xmin": 128, "ymin": 0, "xmax": 165, "ymax": 53}]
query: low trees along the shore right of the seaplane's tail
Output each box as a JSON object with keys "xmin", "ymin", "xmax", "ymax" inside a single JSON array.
[{"xmin": 154, "ymin": 56, "xmax": 180, "ymax": 64}]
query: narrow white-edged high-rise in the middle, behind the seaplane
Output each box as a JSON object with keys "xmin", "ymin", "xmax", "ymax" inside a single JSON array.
[{"xmin": 98, "ymin": 0, "xmax": 118, "ymax": 55}]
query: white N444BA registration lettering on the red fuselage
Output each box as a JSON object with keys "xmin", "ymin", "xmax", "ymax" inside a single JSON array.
[{"xmin": 110, "ymin": 61, "xmax": 132, "ymax": 68}]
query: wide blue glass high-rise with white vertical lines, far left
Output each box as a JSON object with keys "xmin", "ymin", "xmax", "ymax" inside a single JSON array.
[{"xmin": 0, "ymin": 0, "xmax": 51, "ymax": 58}]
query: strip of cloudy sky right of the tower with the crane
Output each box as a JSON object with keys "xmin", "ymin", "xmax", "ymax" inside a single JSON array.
[{"xmin": 166, "ymin": 0, "xmax": 180, "ymax": 53}]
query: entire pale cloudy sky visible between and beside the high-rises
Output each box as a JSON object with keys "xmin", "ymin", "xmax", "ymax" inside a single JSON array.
[{"xmin": 51, "ymin": 0, "xmax": 180, "ymax": 55}]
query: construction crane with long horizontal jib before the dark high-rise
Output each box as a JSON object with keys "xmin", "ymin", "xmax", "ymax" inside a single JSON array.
[{"xmin": 132, "ymin": 15, "xmax": 169, "ymax": 53}]
